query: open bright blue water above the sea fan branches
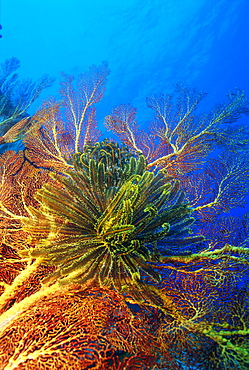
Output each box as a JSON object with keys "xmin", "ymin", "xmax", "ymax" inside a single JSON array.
[{"xmin": 0, "ymin": 0, "xmax": 249, "ymax": 212}]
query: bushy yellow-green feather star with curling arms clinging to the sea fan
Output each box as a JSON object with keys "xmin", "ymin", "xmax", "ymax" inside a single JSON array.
[{"xmin": 21, "ymin": 142, "xmax": 201, "ymax": 291}]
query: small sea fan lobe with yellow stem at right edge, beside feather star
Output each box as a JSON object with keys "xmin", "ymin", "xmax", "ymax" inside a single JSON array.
[{"xmin": 181, "ymin": 152, "xmax": 249, "ymax": 220}]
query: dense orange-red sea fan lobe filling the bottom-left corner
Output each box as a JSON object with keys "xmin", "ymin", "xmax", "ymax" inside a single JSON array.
[{"xmin": 0, "ymin": 287, "xmax": 160, "ymax": 370}]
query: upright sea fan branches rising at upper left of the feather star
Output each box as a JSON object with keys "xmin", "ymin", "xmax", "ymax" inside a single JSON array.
[{"xmin": 24, "ymin": 63, "xmax": 109, "ymax": 172}]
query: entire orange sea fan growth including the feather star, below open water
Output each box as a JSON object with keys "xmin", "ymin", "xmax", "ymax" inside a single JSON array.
[{"xmin": 0, "ymin": 59, "xmax": 249, "ymax": 370}]
